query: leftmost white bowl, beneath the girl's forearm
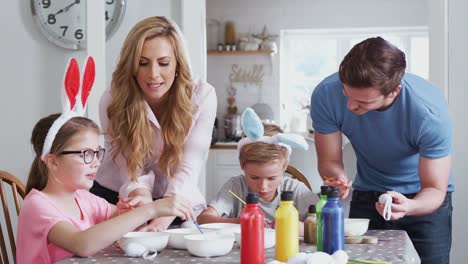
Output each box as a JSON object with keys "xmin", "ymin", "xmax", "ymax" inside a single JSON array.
[{"xmin": 119, "ymin": 232, "xmax": 169, "ymax": 252}]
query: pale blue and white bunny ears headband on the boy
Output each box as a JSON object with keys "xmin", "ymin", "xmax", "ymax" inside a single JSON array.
[{"xmin": 237, "ymin": 107, "xmax": 309, "ymax": 159}]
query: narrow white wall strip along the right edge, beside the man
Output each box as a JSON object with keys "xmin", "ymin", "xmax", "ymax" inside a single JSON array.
[{"xmin": 448, "ymin": 0, "xmax": 468, "ymax": 263}]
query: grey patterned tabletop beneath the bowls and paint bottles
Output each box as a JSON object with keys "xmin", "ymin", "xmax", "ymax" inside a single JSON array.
[{"xmin": 57, "ymin": 230, "xmax": 421, "ymax": 264}]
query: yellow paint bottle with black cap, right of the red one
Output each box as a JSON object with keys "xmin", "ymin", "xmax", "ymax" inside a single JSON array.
[{"xmin": 275, "ymin": 191, "xmax": 299, "ymax": 262}]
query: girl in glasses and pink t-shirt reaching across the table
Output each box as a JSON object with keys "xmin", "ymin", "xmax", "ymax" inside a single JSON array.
[{"xmin": 16, "ymin": 114, "xmax": 194, "ymax": 264}]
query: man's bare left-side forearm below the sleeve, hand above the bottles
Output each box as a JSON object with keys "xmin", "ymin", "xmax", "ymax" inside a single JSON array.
[{"xmin": 314, "ymin": 131, "xmax": 351, "ymax": 199}]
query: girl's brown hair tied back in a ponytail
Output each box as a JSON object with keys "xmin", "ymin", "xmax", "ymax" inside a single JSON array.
[{"xmin": 26, "ymin": 113, "xmax": 99, "ymax": 194}]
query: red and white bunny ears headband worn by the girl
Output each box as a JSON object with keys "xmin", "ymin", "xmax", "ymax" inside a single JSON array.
[{"xmin": 41, "ymin": 57, "xmax": 96, "ymax": 160}]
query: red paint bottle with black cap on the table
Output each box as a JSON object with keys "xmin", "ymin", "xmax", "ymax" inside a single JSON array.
[{"xmin": 240, "ymin": 192, "xmax": 265, "ymax": 264}]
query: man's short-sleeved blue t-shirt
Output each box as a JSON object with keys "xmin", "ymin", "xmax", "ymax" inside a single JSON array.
[{"xmin": 310, "ymin": 73, "xmax": 453, "ymax": 194}]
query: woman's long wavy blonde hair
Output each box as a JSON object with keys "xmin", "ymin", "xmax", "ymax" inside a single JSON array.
[{"xmin": 105, "ymin": 17, "xmax": 193, "ymax": 180}]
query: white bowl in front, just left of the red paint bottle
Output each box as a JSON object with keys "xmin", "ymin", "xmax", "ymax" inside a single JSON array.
[{"xmin": 184, "ymin": 233, "xmax": 234, "ymax": 257}]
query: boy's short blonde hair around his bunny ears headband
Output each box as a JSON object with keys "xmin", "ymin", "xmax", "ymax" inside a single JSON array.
[{"xmin": 239, "ymin": 124, "xmax": 288, "ymax": 168}]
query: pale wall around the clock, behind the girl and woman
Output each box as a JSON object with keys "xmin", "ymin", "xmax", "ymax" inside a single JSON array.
[{"xmin": 0, "ymin": 0, "xmax": 181, "ymax": 186}]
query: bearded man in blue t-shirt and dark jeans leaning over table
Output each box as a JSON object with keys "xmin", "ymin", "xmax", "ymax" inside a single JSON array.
[{"xmin": 311, "ymin": 37, "xmax": 453, "ymax": 263}]
